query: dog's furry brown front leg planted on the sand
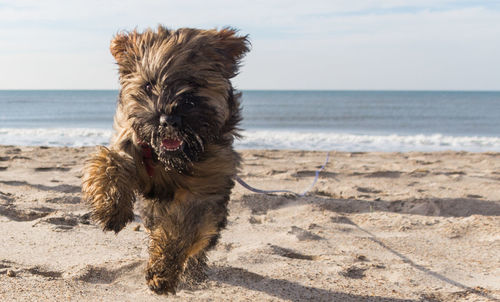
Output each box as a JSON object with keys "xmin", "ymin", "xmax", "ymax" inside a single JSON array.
[{"xmin": 146, "ymin": 194, "xmax": 219, "ymax": 294}]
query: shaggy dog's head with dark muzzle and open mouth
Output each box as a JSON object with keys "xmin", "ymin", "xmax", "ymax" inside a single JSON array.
[{"xmin": 110, "ymin": 26, "xmax": 249, "ymax": 171}]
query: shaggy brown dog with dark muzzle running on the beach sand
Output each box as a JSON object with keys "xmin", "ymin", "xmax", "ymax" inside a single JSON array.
[{"xmin": 82, "ymin": 26, "xmax": 248, "ymax": 293}]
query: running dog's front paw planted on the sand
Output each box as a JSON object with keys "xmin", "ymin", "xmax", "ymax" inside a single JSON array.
[{"xmin": 146, "ymin": 261, "xmax": 181, "ymax": 295}]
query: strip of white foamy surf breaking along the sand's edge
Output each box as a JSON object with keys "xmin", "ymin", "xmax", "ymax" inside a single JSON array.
[{"xmin": 0, "ymin": 128, "xmax": 500, "ymax": 152}]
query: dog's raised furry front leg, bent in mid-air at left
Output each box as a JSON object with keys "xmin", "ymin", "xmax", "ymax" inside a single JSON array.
[{"xmin": 82, "ymin": 147, "xmax": 137, "ymax": 233}]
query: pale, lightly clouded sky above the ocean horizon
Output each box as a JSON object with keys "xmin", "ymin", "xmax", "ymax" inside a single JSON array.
[{"xmin": 0, "ymin": 0, "xmax": 500, "ymax": 90}]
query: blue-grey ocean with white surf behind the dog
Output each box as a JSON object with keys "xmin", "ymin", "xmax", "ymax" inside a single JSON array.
[{"xmin": 0, "ymin": 90, "xmax": 500, "ymax": 152}]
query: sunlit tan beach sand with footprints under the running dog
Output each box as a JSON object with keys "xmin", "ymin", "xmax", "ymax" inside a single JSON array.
[{"xmin": 0, "ymin": 146, "xmax": 500, "ymax": 302}]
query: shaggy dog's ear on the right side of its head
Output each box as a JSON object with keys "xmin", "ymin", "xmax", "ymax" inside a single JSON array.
[{"xmin": 214, "ymin": 28, "xmax": 250, "ymax": 78}]
